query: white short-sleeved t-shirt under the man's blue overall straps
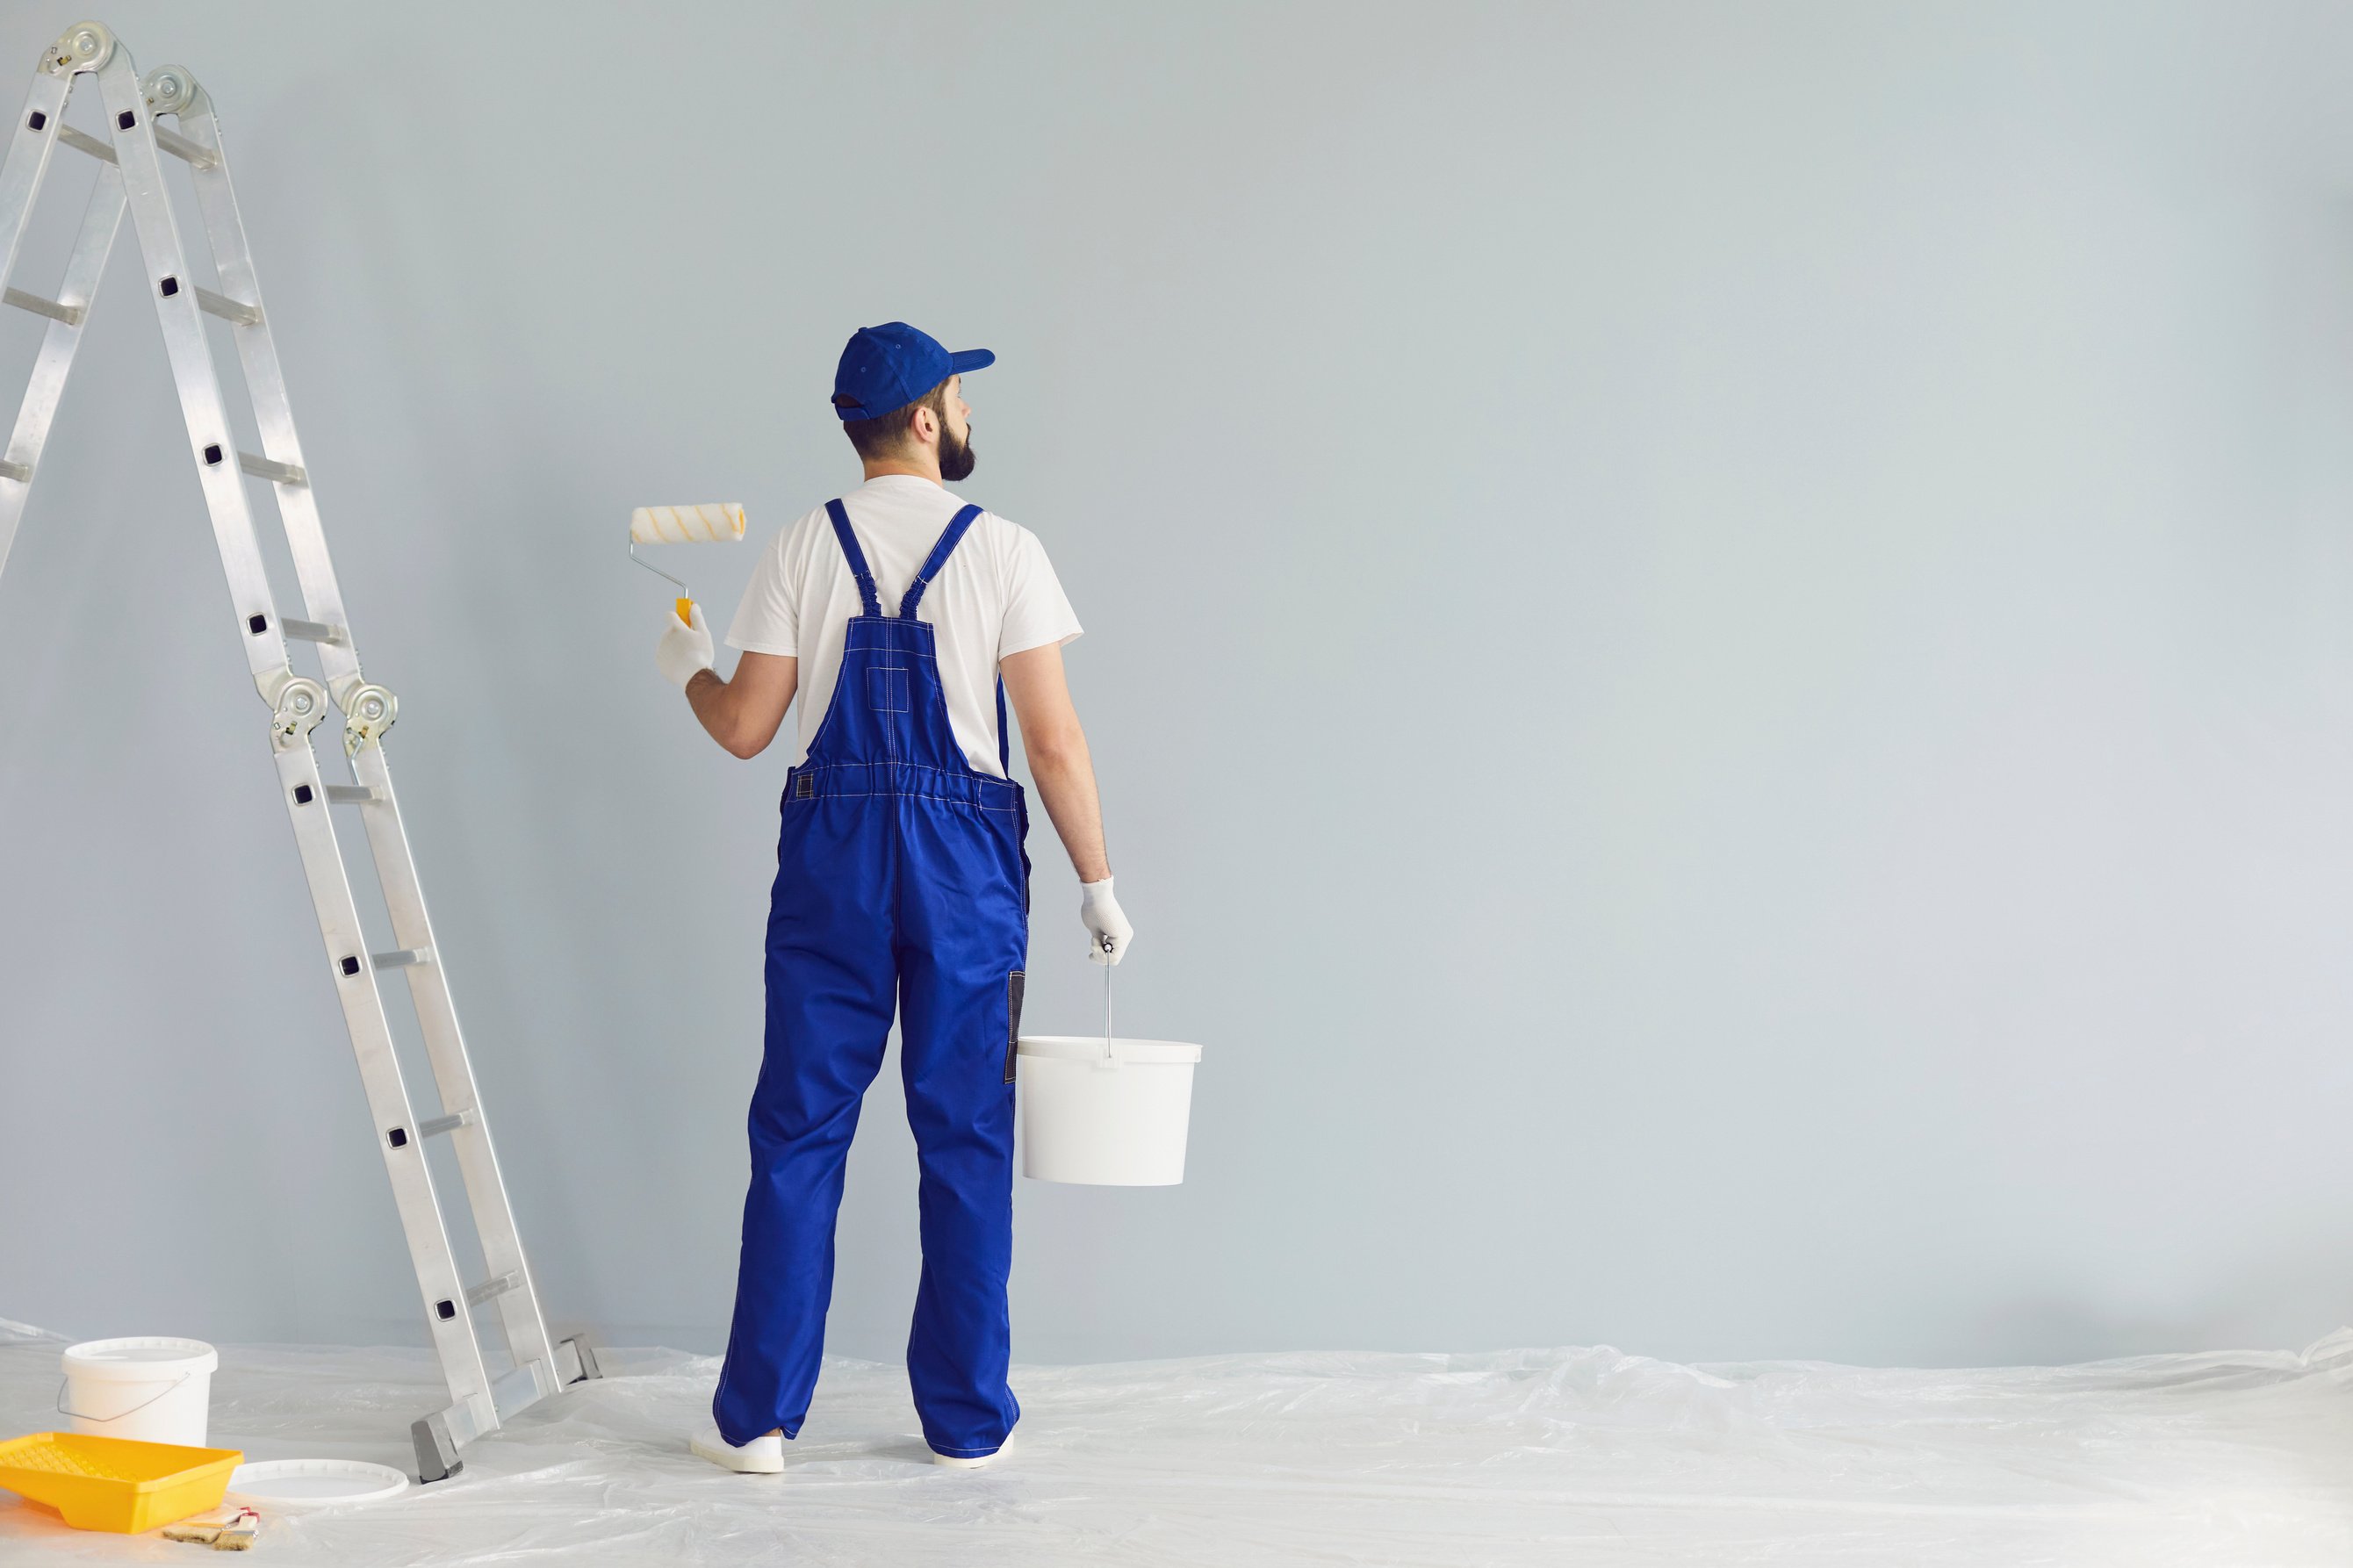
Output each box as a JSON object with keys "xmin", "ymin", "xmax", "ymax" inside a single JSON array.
[{"xmin": 727, "ymin": 473, "xmax": 1083, "ymax": 780}]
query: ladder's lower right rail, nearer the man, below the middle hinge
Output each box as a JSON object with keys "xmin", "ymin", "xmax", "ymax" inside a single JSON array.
[{"xmin": 350, "ymin": 742, "xmax": 563, "ymax": 1394}]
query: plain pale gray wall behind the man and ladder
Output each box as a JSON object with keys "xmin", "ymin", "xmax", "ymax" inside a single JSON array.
[{"xmin": 0, "ymin": 0, "xmax": 2353, "ymax": 1363}]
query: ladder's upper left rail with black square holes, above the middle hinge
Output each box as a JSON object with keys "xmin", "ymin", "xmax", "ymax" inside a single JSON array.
[{"xmin": 99, "ymin": 47, "xmax": 290, "ymax": 682}]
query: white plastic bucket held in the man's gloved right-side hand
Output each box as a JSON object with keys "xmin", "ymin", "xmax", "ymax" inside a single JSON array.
[{"xmin": 1014, "ymin": 1033, "xmax": 1200, "ymax": 1187}]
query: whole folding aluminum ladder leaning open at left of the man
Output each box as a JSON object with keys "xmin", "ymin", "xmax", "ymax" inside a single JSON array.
[{"xmin": 0, "ymin": 21, "xmax": 598, "ymax": 1481}]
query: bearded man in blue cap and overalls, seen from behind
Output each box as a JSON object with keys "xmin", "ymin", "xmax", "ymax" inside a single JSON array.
[{"xmin": 657, "ymin": 320, "xmax": 1132, "ymax": 1471}]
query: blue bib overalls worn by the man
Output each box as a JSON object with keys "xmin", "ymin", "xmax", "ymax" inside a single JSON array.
[{"xmin": 710, "ymin": 501, "xmax": 1031, "ymax": 1457}]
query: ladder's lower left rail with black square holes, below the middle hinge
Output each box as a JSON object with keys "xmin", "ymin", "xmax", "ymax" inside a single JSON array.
[{"xmin": 277, "ymin": 737, "xmax": 489, "ymax": 1408}]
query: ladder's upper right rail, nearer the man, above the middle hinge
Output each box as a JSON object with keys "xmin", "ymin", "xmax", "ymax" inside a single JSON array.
[{"xmin": 165, "ymin": 87, "xmax": 360, "ymax": 692}]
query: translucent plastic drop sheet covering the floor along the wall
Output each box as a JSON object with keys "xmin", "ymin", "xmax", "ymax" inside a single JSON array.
[{"xmin": 0, "ymin": 1320, "xmax": 2353, "ymax": 1568}]
